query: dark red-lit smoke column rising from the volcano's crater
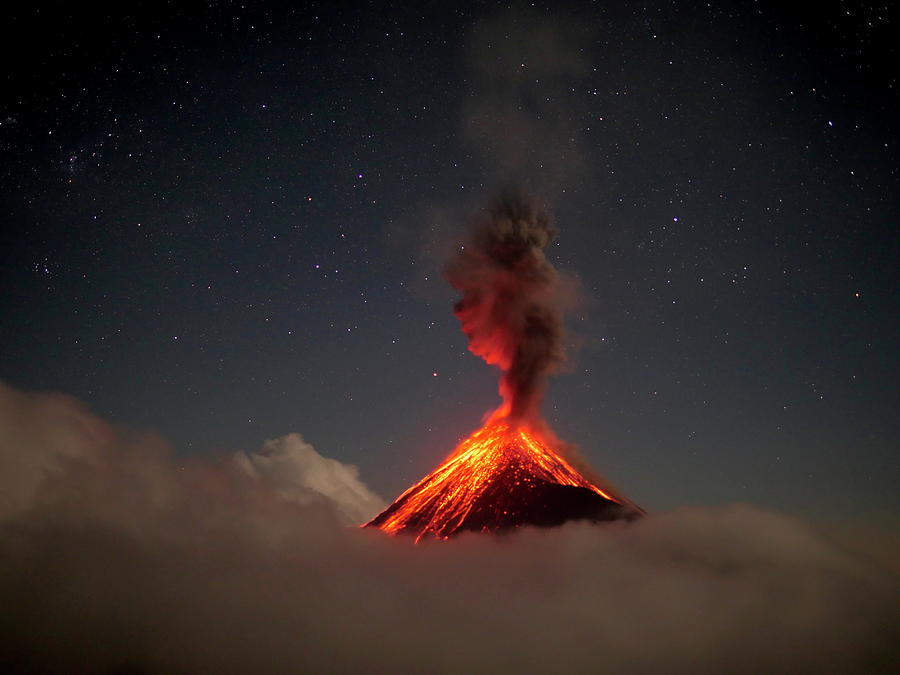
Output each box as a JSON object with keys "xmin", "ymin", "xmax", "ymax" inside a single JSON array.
[{"xmin": 446, "ymin": 191, "xmax": 565, "ymax": 420}]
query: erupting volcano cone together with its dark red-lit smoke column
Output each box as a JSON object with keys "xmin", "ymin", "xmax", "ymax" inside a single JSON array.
[{"xmin": 365, "ymin": 193, "xmax": 642, "ymax": 541}]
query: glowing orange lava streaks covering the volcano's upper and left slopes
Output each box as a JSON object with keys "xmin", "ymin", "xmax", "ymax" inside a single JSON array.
[{"xmin": 367, "ymin": 409, "xmax": 621, "ymax": 541}]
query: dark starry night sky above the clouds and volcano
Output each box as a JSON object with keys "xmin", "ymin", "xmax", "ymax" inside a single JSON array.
[{"xmin": 0, "ymin": 1, "xmax": 900, "ymax": 518}]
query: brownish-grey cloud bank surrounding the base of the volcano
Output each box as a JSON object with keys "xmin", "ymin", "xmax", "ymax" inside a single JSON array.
[{"xmin": 0, "ymin": 386, "xmax": 900, "ymax": 673}]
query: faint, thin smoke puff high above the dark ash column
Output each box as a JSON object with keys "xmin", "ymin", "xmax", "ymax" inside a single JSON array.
[{"xmin": 461, "ymin": 7, "xmax": 596, "ymax": 193}]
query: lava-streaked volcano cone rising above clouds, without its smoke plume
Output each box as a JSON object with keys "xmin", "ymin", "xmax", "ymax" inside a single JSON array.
[{"xmin": 365, "ymin": 418, "xmax": 642, "ymax": 541}]
